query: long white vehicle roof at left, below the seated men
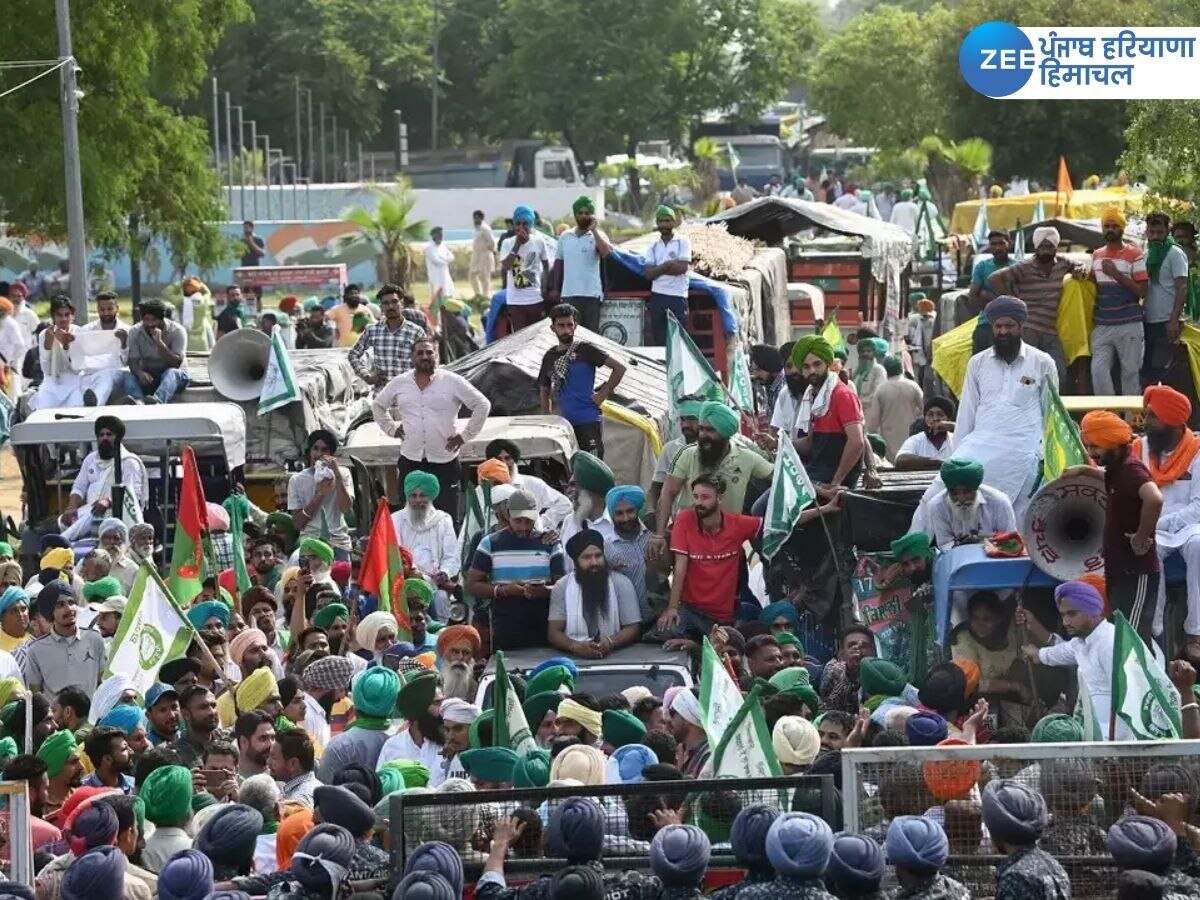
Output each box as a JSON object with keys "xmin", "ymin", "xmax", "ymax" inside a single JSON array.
[{"xmin": 11, "ymin": 403, "xmax": 246, "ymax": 469}]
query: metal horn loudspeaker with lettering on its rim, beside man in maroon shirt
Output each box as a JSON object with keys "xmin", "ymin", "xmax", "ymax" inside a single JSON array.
[{"xmin": 1021, "ymin": 475, "xmax": 1108, "ymax": 581}]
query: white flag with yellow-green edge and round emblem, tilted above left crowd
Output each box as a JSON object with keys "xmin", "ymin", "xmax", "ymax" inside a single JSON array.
[{"xmin": 104, "ymin": 563, "xmax": 196, "ymax": 696}]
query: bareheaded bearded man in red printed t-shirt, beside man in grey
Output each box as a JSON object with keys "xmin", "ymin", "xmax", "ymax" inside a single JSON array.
[{"xmin": 658, "ymin": 475, "xmax": 762, "ymax": 635}]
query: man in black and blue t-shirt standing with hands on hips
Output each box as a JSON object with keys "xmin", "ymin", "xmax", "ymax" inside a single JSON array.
[{"xmin": 538, "ymin": 304, "xmax": 625, "ymax": 460}]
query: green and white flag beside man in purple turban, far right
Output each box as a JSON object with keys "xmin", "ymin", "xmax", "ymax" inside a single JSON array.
[{"xmin": 1108, "ymin": 610, "xmax": 1183, "ymax": 740}]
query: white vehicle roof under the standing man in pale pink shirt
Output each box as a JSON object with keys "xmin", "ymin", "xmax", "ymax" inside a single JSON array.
[{"xmin": 337, "ymin": 415, "xmax": 580, "ymax": 466}]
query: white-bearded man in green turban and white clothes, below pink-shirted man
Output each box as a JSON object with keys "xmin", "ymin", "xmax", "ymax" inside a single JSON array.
[{"xmin": 391, "ymin": 469, "xmax": 462, "ymax": 622}]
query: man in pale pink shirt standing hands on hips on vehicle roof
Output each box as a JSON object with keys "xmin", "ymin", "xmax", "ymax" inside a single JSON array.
[{"xmin": 371, "ymin": 336, "xmax": 492, "ymax": 517}]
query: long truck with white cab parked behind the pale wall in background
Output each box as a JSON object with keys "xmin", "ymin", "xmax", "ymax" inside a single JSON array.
[{"xmin": 403, "ymin": 139, "xmax": 583, "ymax": 188}]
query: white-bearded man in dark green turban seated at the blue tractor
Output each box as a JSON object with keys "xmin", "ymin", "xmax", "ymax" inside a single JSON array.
[{"xmin": 912, "ymin": 458, "xmax": 1016, "ymax": 552}]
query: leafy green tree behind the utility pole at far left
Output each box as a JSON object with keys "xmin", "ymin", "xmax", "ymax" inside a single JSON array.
[{"xmin": 0, "ymin": 0, "xmax": 247, "ymax": 266}]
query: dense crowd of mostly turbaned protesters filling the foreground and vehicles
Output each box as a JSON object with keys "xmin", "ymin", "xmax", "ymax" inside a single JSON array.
[{"xmin": 0, "ymin": 198, "xmax": 1200, "ymax": 900}]
